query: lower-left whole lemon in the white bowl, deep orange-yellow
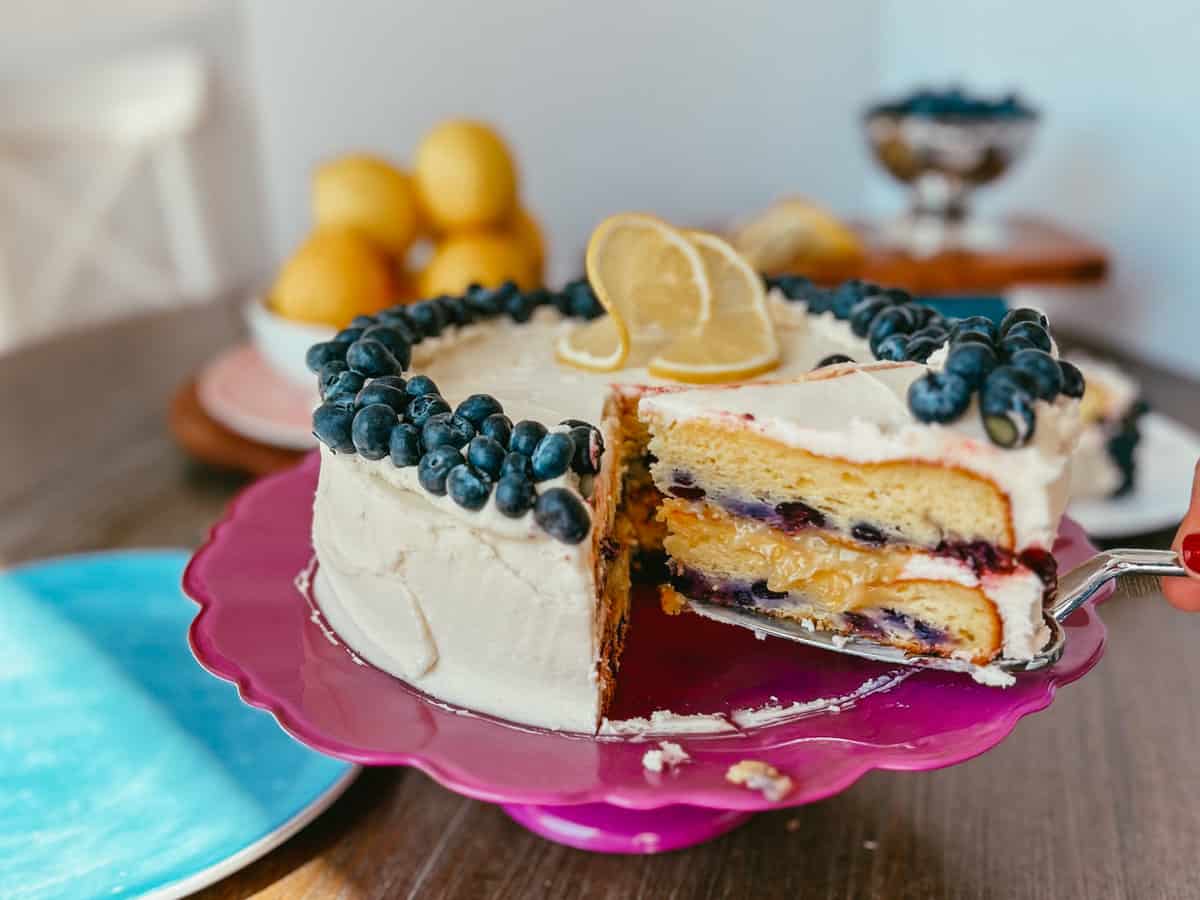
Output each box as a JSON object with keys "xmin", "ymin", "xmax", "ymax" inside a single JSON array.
[{"xmin": 269, "ymin": 228, "xmax": 395, "ymax": 328}]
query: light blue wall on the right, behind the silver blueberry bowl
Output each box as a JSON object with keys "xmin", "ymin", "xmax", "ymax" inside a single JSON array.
[{"xmin": 872, "ymin": 0, "xmax": 1200, "ymax": 374}]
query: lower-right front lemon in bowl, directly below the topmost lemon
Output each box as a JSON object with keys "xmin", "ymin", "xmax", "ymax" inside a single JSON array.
[{"xmin": 420, "ymin": 232, "xmax": 539, "ymax": 296}]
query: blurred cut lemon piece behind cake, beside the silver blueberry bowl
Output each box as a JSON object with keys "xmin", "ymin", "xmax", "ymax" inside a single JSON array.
[{"xmin": 733, "ymin": 197, "xmax": 863, "ymax": 272}]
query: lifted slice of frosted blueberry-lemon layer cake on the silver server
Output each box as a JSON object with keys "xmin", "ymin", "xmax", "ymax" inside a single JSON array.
[{"xmin": 640, "ymin": 362, "xmax": 1079, "ymax": 664}]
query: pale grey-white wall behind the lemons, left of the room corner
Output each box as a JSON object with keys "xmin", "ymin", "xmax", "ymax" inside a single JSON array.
[{"xmin": 245, "ymin": 0, "xmax": 880, "ymax": 278}]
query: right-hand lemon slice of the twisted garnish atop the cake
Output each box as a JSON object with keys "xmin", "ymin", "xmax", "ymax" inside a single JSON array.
[{"xmin": 649, "ymin": 232, "xmax": 779, "ymax": 384}]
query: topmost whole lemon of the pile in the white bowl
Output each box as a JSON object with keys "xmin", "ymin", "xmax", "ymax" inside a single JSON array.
[{"xmin": 413, "ymin": 119, "xmax": 517, "ymax": 232}]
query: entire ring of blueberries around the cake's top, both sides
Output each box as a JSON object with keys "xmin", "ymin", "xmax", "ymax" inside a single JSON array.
[{"xmin": 305, "ymin": 275, "xmax": 1084, "ymax": 544}]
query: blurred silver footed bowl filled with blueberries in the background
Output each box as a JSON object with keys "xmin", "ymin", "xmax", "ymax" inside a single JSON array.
[{"xmin": 863, "ymin": 88, "xmax": 1038, "ymax": 222}]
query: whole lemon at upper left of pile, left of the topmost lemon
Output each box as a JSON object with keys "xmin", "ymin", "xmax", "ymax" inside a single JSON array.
[{"xmin": 312, "ymin": 155, "xmax": 420, "ymax": 257}]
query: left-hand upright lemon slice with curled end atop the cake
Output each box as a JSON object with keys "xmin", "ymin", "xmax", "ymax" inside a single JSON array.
[{"xmin": 558, "ymin": 212, "xmax": 713, "ymax": 372}]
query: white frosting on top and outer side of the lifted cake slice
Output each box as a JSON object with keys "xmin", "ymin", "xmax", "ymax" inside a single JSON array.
[{"xmin": 641, "ymin": 362, "xmax": 1079, "ymax": 548}]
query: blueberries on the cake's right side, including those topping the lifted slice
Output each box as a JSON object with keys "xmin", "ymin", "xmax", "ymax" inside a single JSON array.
[{"xmin": 767, "ymin": 275, "xmax": 1084, "ymax": 448}]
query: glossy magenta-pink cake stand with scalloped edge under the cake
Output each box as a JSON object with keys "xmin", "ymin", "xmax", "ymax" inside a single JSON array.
[{"xmin": 184, "ymin": 454, "xmax": 1105, "ymax": 853}]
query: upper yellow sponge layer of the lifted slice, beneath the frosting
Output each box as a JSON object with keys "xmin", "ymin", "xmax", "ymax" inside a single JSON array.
[{"xmin": 649, "ymin": 420, "xmax": 1013, "ymax": 550}]
